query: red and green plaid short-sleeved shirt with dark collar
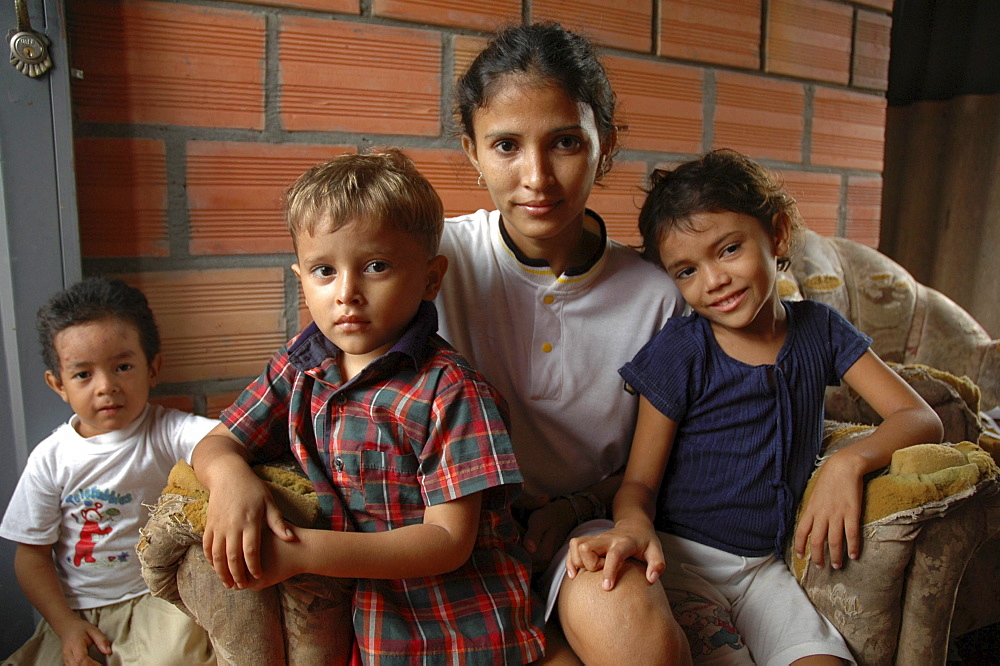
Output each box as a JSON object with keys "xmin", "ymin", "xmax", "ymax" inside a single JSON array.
[{"xmin": 221, "ymin": 301, "xmax": 543, "ymax": 664}]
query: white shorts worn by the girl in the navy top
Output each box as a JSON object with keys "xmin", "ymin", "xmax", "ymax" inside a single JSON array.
[{"xmin": 658, "ymin": 532, "xmax": 854, "ymax": 666}]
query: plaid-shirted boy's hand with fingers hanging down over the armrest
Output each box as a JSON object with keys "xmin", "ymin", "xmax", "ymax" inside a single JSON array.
[{"xmin": 202, "ymin": 466, "xmax": 294, "ymax": 589}]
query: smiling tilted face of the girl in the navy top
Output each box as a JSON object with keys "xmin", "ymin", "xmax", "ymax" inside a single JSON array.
[{"xmin": 660, "ymin": 211, "xmax": 789, "ymax": 330}]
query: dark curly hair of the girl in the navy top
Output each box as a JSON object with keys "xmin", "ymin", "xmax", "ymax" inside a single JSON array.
[{"xmin": 639, "ymin": 148, "xmax": 804, "ymax": 267}]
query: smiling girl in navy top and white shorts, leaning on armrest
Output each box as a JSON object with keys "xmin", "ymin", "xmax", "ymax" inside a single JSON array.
[{"xmin": 567, "ymin": 151, "xmax": 942, "ymax": 664}]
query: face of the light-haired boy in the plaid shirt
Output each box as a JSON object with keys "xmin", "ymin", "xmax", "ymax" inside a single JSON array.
[{"xmin": 292, "ymin": 221, "xmax": 448, "ymax": 376}]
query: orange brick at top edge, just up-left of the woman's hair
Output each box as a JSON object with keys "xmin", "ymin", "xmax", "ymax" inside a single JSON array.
[{"xmin": 372, "ymin": 0, "xmax": 521, "ymax": 32}]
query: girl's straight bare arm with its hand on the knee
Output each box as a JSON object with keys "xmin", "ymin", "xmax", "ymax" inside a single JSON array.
[{"xmin": 566, "ymin": 397, "xmax": 677, "ymax": 590}]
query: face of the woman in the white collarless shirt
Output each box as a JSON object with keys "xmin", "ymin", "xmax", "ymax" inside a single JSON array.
[{"xmin": 462, "ymin": 75, "xmax": 610, "ymax": 258}]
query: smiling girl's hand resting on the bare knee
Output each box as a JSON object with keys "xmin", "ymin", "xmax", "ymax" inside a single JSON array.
[{"xmin": 566, "ymin": 524, "xmax": 666, "ymax": 590}]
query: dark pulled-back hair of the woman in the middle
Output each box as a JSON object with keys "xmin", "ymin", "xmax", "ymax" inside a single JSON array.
[{"xmin": 455, "ymin": 22, "xmax": 618, "ymax": 171}]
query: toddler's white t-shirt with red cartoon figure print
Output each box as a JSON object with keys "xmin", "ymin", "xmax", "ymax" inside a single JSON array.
[{"xmin": 0, "ymin": 405, "xmax": 218, "ymax": 609}]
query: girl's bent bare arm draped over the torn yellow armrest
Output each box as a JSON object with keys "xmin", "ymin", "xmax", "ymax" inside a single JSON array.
[{"xmin": 795, "ymin": 350, "xmax": 944, "ymax": 569}]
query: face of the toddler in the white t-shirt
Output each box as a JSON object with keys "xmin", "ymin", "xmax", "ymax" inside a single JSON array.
[{"xmin": 45, "ymin": 317, "xmax": 160, "ymax": 437}]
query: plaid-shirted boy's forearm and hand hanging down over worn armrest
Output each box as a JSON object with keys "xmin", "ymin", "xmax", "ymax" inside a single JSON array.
[{"xmin": 191, "ymin": 424, "xmax": 293, "ymax": 589}]
